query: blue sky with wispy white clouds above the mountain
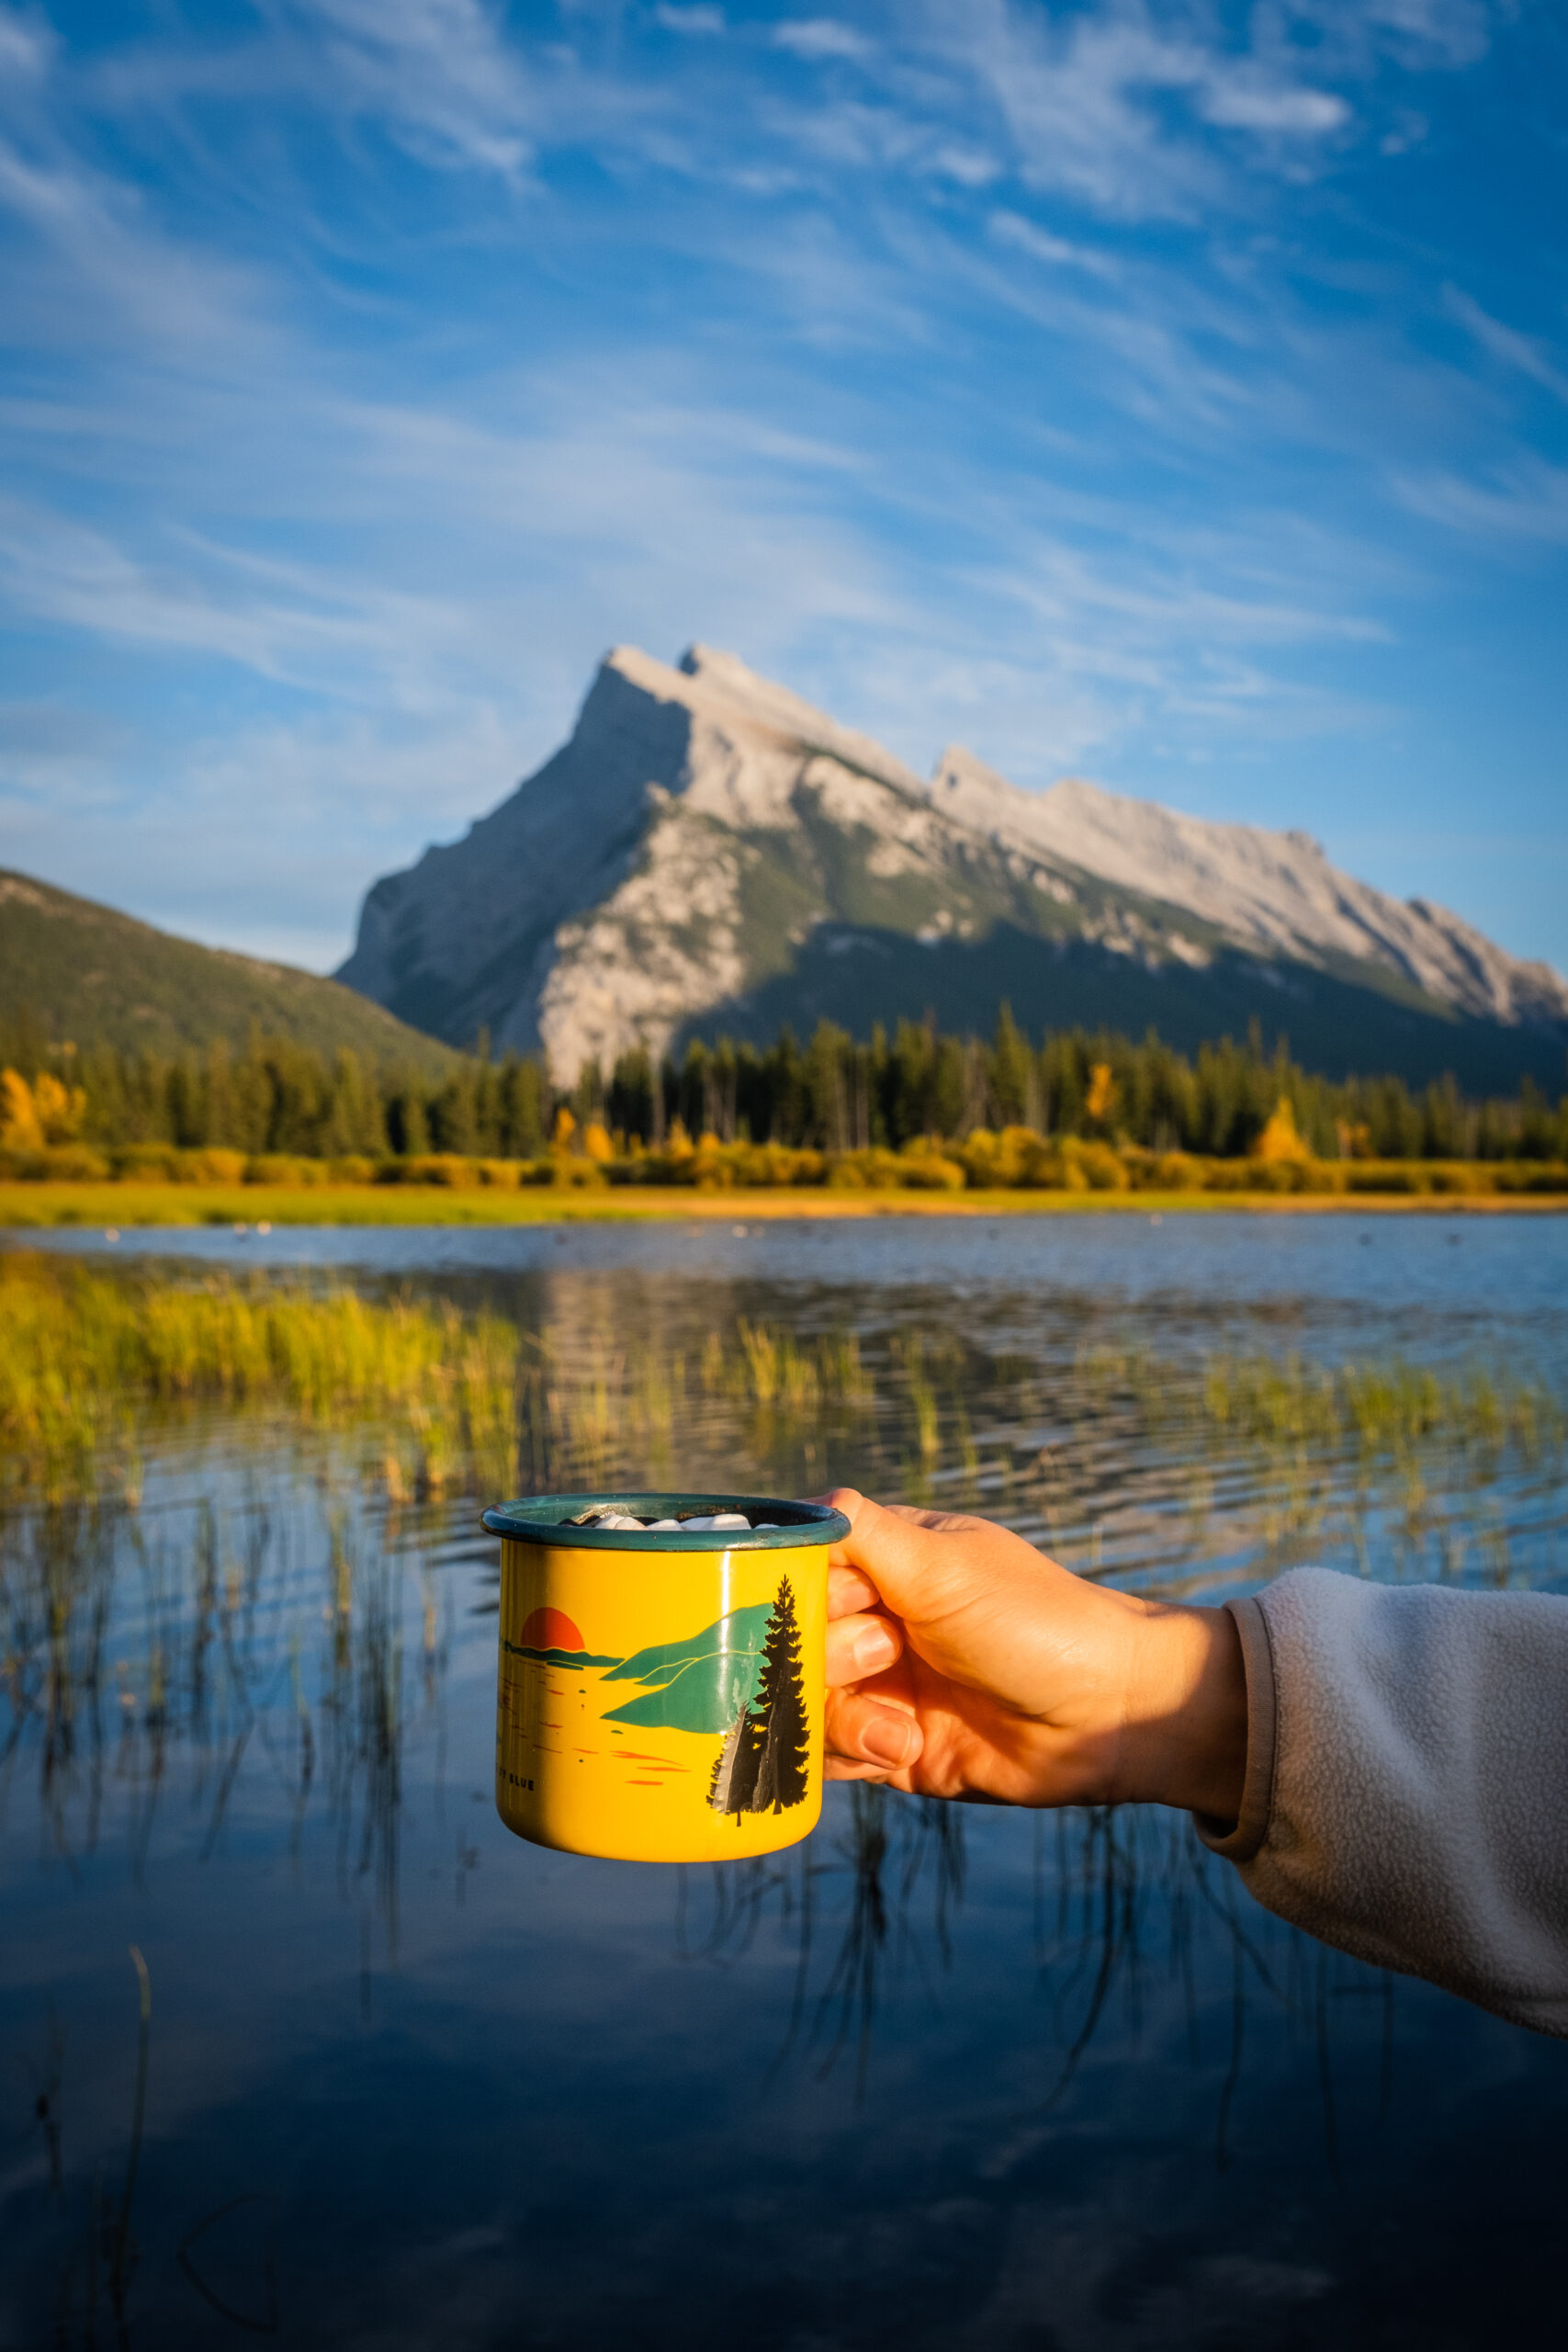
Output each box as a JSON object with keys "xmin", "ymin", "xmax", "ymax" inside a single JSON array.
[{"xmin": 0, "ymin": 0, "xmax": 1568, "ymax": 969}]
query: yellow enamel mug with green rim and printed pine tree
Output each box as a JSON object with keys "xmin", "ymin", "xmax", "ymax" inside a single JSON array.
[{"xmin": 484, "ymin": 1494, "xmax": 849, "ymax": 1863}]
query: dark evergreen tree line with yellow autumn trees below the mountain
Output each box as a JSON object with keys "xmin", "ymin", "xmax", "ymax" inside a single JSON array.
[{"xmin": 0, "ymin": 1007, "xmax": 1568, "ymax": 1159}]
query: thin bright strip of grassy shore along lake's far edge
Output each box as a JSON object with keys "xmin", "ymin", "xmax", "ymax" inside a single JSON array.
[{"xmin": 0, "ymin": 1183, "xmax": 1568, "ymax": 1232}]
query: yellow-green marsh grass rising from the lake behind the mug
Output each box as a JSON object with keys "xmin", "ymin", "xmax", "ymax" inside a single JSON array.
[{"xmin": 0, "ymin": 1256, "xmax": 1565, "ymax": 1529}]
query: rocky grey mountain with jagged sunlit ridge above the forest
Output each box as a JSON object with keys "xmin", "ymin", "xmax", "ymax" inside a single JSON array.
[{"xmin": 339, "ymin": 644, "xmax": 1568, "ymax": 1084}]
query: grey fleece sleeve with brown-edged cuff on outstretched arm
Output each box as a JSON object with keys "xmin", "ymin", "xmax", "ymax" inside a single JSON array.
[{"xmin": 1199, "ymin": 1569, "xmax": 1568, "ymax": 2034}]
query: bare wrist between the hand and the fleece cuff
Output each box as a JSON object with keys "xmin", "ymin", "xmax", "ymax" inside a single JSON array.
[{"xmin": 1117, "ymin": 1601, "xmax": 1246, "ymax": 1820}]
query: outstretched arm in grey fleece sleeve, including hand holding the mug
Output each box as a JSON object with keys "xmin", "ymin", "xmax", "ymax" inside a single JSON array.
[{"xmin": 828, "ymin": 1494, "xmax": 1568, "ymax": 2034}]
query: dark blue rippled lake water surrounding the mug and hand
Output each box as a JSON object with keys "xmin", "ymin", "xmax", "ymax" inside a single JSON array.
[{"xmin": 0, "ymin": 1209, "xmax": 1568, "ymax": 2352}]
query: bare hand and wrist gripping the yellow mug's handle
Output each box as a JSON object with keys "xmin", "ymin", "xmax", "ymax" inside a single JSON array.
[{"xmin": 825, "ymin": 1487, "xmax": 1246, "ymax": 1820}]
